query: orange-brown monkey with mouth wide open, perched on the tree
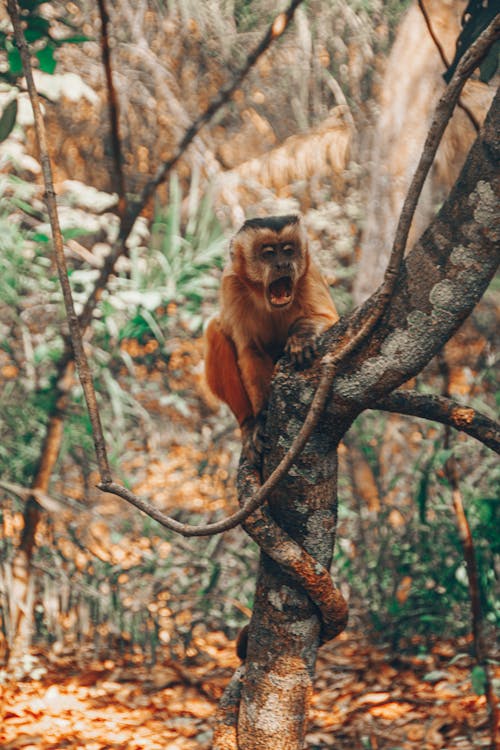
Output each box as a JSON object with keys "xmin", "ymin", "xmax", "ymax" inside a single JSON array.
[{"xmin": 205, "ymin": 215, "xmax": 338, "ymax": 455}]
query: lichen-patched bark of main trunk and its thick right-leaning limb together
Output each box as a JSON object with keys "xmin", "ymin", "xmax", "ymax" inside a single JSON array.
[{"xmin": 232, "ymin": 86, "xmax": 500, "ymax": 750}]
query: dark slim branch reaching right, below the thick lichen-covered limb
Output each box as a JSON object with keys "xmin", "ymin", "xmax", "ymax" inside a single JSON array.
[{"xmin": 372, "ymin": 391, "xmax": 500, "ymax": 453}]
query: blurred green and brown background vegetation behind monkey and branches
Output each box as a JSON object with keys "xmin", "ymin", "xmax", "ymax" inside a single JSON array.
[{"xmin": 0, "ymin": 0, "xmax": 500, "ymax": 748}]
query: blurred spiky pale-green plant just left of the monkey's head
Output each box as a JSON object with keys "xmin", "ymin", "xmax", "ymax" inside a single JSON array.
[{"xmin": 101, "ymin": 175, "xmax": 224, "ymax": 345}]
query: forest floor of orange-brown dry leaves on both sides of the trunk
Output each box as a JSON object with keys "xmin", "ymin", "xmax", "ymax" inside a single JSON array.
[{"xmin": 0, "ymin": 631, "xmax": 494, "ymax": 750}]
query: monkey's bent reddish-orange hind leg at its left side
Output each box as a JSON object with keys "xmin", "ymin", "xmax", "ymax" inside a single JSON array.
[{"xmin": 205, "ymin": 318, "xmax": 253, "ymax": 426}]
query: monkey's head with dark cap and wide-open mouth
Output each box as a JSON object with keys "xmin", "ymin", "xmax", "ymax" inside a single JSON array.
[{"xmin": 232, "ymin": 216, "xmax": 308, "ymax": 312}]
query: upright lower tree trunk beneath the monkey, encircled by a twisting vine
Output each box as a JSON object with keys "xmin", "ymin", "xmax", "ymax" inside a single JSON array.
[{"xmin": 238, "ymin": 394, "xmax": 352, "ymax": 750}]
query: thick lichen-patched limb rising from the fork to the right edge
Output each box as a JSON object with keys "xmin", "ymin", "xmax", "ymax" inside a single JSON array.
[{"xmin": 325, "ymin": 86, "xmax": 500, "ymax": 414}]
